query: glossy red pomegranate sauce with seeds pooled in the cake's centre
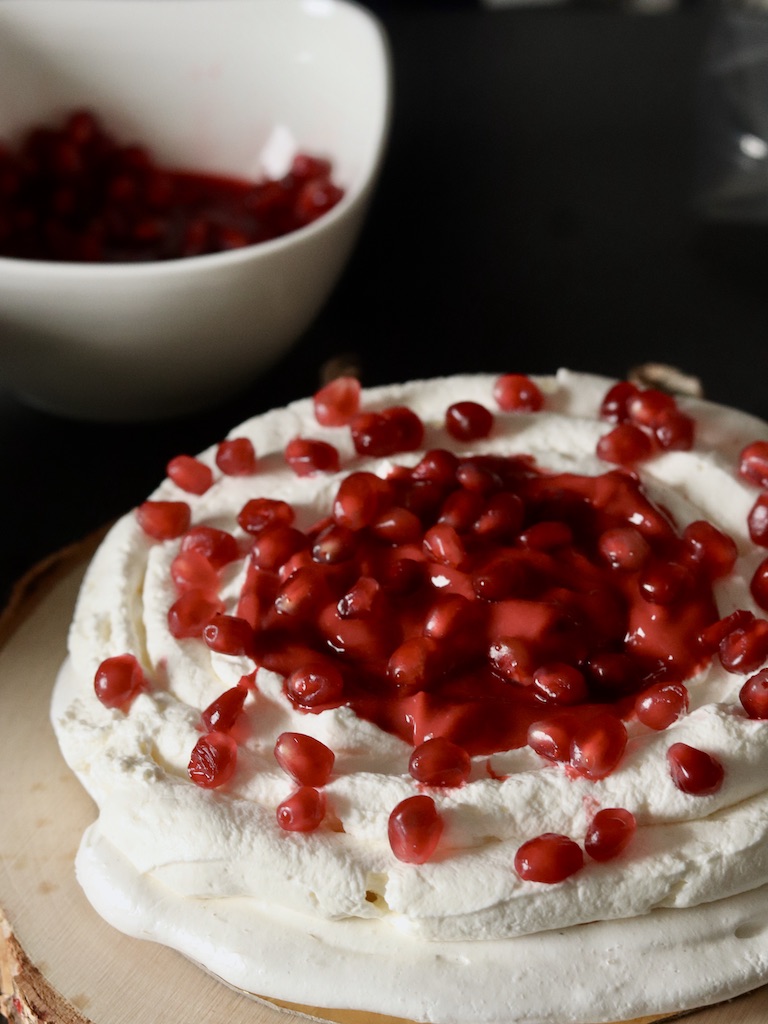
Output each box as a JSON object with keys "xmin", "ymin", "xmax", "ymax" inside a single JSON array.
[{"xmin": 240, "ymin": 453, "xmax": 717, "ymax": 761}]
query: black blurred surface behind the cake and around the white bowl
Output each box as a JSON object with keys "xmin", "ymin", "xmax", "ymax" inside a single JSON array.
[{"xmin": 0, "ymin": 2, "xmax": 768, "ymax": 604}]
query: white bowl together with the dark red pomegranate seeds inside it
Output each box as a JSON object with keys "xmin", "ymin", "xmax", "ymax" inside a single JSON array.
[{"xmin": 0, "ymin": 0, "xmax": 390, "ymax": 421}]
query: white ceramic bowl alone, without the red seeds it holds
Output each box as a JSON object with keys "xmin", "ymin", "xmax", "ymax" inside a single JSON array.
[{"xmin": 0, "ymin": 0, "xmax": 390, "ymax": 420}]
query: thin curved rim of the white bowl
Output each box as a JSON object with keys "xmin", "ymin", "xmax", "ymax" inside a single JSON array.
[{"xmin": 0, "ymin": 0, "xmax": 393, "ymax": 279}]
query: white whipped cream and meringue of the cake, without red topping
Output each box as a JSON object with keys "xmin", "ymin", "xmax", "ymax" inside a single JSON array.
[{"xmin": 52, "ymin": 371, "xmax": 768, "ymax": 1024}]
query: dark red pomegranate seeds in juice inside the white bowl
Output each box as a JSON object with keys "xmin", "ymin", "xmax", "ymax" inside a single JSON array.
[{"xmin": 0, "ymin": 111, "xmax": 343, "ymax": 262}]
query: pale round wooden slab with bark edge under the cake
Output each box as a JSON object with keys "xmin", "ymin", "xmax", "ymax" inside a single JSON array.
[{"xmin": 0, "ymin": 538, "xmax": 768, "ymax": 1024}]
